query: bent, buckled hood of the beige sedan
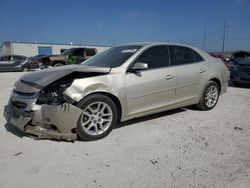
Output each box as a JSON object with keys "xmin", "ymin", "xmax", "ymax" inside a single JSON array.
[{"xmin": 21, "ymin": 65, "xmax": 111, "ymax": 88}]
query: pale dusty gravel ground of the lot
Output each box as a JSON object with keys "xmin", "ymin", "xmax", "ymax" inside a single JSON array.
[{"xmin": 0, "ymin": 73, "xmax": 250, "ymax": 188}]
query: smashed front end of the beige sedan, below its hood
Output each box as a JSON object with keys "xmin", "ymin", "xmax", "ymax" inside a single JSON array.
[{"xmin": 4, "ymin": 65, "xmax": 111, "ymax": 140}]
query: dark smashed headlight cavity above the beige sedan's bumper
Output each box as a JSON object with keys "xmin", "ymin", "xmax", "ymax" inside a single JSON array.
[{"xmin": 37, "ymin": 80, "xmax": 73, "ymax": 105}]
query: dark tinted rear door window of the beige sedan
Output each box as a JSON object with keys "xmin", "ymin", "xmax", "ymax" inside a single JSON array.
[{"xmin": 169, "ymin": 46, "xmax": 195, "ymax": 65}]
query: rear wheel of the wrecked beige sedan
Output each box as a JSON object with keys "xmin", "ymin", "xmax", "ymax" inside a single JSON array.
[{"xmin": 196, "ymin": 81, "xmax": 219, "ymax": 110}]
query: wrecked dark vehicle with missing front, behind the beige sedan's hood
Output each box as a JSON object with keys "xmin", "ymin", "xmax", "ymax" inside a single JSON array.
[{"xmin": 42, "ymin": 48, "xmax": 97, "ymax": 68}]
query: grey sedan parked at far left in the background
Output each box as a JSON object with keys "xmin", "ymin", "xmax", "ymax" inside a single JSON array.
[{"xmin": 0, "ymin": 55, "xmax": 27, "ymax": 71}]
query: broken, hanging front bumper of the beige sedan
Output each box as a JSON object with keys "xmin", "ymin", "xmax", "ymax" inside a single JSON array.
[{"xmin": 4, "ymin": 99, "xmax": 82, "ymax": 140}]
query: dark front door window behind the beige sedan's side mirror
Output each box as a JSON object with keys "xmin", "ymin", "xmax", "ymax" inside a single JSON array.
[{"xmin": 136, "ymin": 46, "xmax": 169, "ymax": 69}]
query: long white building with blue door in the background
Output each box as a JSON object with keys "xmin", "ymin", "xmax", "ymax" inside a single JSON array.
[{"xmin": 0, "ymin": 41, "xmax": 108, "ymax": 57}]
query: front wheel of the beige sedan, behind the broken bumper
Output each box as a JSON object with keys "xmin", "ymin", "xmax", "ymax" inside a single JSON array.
[{"xmin": 76, "ymin": 94, "xmax": 117, "ymax": 141}]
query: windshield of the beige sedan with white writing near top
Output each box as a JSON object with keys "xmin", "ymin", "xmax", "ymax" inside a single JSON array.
[{"xmin": 82, "ymin": 46, "xmax": 142, "ymax": 68}]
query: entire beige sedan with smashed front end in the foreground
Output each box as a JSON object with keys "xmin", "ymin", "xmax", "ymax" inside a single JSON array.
[{"xmin": 4, "ymin": 43, "xmax": 228, "ymax": 140}]
